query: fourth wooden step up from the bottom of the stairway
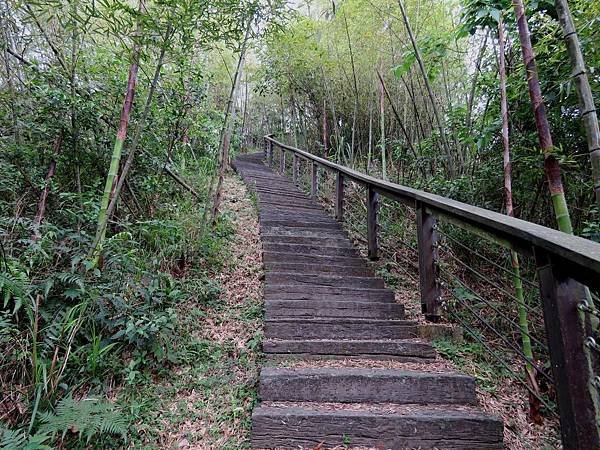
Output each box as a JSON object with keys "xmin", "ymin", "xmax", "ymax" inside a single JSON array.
[{"xmin": 264, "ymin": 318, "xmax": 419, "ymax": 339}]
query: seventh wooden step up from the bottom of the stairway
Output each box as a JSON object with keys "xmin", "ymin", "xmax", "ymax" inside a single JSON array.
[{"xmin": 265, "ymin": 267, "xmax": 384, "ymax": 290}]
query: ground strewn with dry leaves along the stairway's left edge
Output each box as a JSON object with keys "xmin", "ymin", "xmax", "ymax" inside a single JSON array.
[{"xmin": 122, "ymin": 171, "xmax": 263, "ymax": 450}]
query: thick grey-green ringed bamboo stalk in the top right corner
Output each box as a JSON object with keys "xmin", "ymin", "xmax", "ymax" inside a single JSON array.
[{"xmin": 554, "ymin": 0, "xmax": 600, "ymax": 207}]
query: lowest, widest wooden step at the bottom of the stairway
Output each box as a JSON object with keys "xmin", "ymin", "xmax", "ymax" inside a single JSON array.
[{"xmin": 252, "ymin": 406, "xmax": 503, "ymax": 450}]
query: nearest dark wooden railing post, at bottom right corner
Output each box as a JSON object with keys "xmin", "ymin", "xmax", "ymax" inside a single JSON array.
[{"xmin": 535, "ymin": 249, "xmax": 600, "ymax": 450}]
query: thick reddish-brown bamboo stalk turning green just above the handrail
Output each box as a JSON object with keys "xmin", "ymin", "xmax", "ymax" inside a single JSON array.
[{"xmin": 513, "ymin": 0, "xmax": 573, "ymax": 234}]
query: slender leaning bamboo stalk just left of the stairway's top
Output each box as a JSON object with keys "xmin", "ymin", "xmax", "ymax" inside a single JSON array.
[{"xmin": 212, "ymin": 18, "xmax": 251, "ymax": 226}]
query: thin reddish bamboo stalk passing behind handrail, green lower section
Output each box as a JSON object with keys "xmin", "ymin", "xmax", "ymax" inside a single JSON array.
[{"xmin": 500, "ymin": 19, "xmax": 542, "ymax": 424}]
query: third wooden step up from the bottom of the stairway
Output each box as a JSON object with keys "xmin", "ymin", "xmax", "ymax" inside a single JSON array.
[{"xmin": 263, "ymin": 339, "xmax": 435, "ymax": 361}]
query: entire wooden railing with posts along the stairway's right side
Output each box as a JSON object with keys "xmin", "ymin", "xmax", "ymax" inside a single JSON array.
[{"xmin": 264, "ymin": 135, "xmax": 600, "ymax": 450}]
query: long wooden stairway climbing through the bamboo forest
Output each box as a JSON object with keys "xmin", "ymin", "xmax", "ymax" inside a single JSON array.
[{"xmin": 235, "ymin": 154, "xmax": 503, "ymax": 449}]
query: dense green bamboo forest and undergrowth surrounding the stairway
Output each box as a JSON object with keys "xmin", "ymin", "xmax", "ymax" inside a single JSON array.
[{"xmin": 0, "ymin": 0, "xmax": 600, "ymax": 448}]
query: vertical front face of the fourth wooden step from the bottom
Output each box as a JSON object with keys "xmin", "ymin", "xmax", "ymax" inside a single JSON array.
[{"xmin": 264, "ymin": 321, "xmax": 418, "ymax": 339}]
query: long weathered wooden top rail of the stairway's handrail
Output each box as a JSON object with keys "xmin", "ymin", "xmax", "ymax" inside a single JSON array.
[{"xmin": 265, "ymin": 135, "xmax": 600, "ymax": 282}]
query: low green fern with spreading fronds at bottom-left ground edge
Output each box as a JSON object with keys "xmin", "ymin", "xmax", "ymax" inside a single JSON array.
[{"xmin": 40, "ymin": 397, "xmax": 127, "ymax": 442}]
